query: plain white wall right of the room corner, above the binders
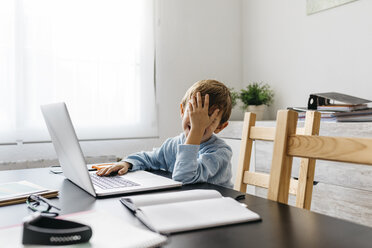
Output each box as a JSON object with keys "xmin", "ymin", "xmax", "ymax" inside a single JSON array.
[{"xmin": 243, "ymin": 0, "xmax": 372, "ymax": 118}]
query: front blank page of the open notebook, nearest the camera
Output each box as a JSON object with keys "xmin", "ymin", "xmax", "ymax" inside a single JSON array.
[{"xmin": 136, "ymin": 197, "xmax": 260, "ymax": 233}]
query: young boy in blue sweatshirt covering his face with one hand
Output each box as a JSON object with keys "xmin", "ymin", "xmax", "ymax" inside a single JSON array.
[{"xmin": 97, "ymin": 80, "xmax": 232, "ymax": 188}]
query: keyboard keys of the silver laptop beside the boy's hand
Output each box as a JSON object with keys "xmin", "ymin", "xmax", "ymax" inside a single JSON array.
[{"xmin": 90, "ymin": 173, "xmax": 139, "ymax": 189}]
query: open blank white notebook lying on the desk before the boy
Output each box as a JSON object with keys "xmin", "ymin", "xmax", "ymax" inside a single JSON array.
[{"xmin": 120, "ymin": 190, "xmax": 260, "ymax": 233}]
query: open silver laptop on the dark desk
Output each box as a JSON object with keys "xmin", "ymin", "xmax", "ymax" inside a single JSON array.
[{"xmin": 41, "ymin": 102, "xmax": 182, "ymax": 197}]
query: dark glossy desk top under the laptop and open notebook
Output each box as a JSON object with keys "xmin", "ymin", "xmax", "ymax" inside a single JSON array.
[{"xmin": 0, "ymin": 168, "xmax": 372, "ymax": 247}]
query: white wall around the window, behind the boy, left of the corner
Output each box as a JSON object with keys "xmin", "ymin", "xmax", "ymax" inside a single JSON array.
[{"xmin": 0, "ymin": 0, "xmax": 242, "ymax": 166}]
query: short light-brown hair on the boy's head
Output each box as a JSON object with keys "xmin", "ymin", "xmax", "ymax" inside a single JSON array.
[{"xmin": 181, "ymin": 79, "xmax": 232, "ymax": 124}]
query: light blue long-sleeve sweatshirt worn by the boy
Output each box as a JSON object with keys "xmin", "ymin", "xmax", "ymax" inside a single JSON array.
[{"xmin": 123, "ymin": 133, "xmax": 232, "ymax": 188}]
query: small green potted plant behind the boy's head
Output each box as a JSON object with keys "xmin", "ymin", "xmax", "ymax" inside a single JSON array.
[{"xmin": 239, "ymin": 82, "xmax": 274, "ymax": 120}]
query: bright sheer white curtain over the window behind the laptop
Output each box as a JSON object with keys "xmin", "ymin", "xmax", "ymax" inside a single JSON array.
[{"xmin": 0, "ymin": 0, "xmax": 157, "ymax": 143}]
